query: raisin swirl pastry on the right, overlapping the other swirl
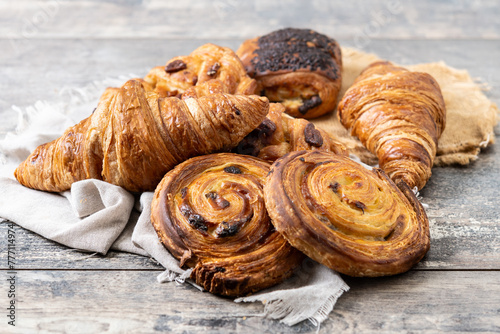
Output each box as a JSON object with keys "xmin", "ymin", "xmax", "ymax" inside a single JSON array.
[{"xmin": 264, "ymin": 150, "xmax": 429, "ymax": 276}]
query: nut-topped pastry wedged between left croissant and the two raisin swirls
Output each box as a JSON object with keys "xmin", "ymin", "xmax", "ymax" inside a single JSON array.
[{"xmin": 233, "ymin": 103, "xmax": 348, "ymax": 162}]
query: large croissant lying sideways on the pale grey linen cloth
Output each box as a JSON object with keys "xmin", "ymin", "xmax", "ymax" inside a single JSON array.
[{"xmin": 15, "ymin": 80, "xmax": 269, "ymax": 192}]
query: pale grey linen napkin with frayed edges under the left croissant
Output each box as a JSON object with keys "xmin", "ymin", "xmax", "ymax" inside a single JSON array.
[{"xmin": 0, "ymin": 74, "xmax": 349, "ymax": 326}]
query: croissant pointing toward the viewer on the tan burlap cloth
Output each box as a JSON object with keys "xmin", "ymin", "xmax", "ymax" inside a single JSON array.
[{"xmin": 338, "ymin": 62, "xmax": 446, "ymax": 189}]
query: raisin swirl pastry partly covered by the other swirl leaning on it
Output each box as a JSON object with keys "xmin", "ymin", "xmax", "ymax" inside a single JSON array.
[{"xmin": 151, "ymin": 153, "xmax": 303, "ymax": 296}]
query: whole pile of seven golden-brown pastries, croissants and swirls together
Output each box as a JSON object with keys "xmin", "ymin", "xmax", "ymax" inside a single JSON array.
[{"xmin": 15, "ymin": 28, "xmax": 446, "ymax": 296}]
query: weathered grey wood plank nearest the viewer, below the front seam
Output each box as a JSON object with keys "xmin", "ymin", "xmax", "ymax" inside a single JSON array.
[{"xmin": 0, "ymin": 271, "xmax": 500, "ymax": 333}]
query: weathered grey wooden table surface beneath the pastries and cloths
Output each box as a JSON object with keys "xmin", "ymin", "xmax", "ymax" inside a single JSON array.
[{"xmin": 0, "ymin": 0, "xmax": 500, "ymax": 333}]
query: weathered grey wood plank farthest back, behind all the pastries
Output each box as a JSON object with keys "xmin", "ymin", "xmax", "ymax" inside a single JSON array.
[{"xmin": 0, "ymin": 0, "xmax": 500, "ymax": 40}]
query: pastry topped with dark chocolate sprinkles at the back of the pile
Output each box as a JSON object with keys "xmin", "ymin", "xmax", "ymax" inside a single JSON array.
[{"xmin": 236, "ymin": 28, "xmax": 342, "ymax": 118}]
